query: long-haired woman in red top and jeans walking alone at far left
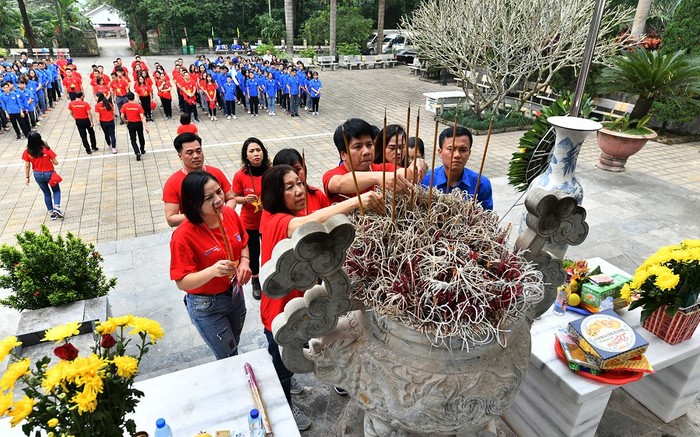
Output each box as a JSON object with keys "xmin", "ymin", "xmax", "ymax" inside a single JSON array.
[{"xmin": 22, "ymin": 131, "xmax": 63, "ymax": 220}]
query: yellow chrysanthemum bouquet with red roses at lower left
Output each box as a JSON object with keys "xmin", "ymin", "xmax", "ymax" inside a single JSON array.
[{"xmin": 0, "ymin": 315, "xmax": 163, "ymax": 437}]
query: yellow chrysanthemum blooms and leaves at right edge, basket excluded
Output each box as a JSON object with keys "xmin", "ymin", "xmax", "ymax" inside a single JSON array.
[{"xmin": 620, "ymin": 240, "xmax": 700, "ymax": 323}]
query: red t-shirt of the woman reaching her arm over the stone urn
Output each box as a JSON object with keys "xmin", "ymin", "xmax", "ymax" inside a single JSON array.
[{"xmin": 260, "ymin": 211, "xmax": 304, "ymax": 332}]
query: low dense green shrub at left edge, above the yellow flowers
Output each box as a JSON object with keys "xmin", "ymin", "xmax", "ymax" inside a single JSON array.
[{"xmin": 0, "ymin": 225, "xmax": 117, "ymax": 311}]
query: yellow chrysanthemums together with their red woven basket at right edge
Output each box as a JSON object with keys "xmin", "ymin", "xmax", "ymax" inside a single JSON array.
[{"xmin": 620, "ymin": 240, "xmax": 700, "ymax": 344}]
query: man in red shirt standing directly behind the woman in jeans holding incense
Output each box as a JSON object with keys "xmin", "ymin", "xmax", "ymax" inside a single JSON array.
[{"xmin": 163, "ymin": 132, "xmax": 236, "ymax": 227}]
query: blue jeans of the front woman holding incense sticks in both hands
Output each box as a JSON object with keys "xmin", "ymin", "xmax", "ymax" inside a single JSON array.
[{"xmin": 185, "ymin": 282, "xmax": 246, "ymax": 360}]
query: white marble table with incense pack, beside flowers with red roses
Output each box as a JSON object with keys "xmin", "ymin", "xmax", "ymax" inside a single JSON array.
[{"xmin": 0, "ymin": 349, "xmax": 299, "ymax": 437}]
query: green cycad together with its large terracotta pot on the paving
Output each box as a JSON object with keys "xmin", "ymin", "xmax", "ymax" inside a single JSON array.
[{"xmin": 597, "ymin": 48, "xmax": 700, "ymax": 172}]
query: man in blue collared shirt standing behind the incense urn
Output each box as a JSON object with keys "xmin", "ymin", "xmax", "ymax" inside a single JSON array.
[{"xmin": 421, "ymin": 126, "xmax": 493, "ymax": 210}]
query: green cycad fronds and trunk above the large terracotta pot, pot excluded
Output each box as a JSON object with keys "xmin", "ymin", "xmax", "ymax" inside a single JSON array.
[{"xmin": 596, "ymin": 48, "xmax": 700, "ymax": 129}]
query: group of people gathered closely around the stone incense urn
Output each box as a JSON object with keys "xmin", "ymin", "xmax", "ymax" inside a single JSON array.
[{"xmin": 163, "ymin": 115, "xmax": 493, "ymax": 430}]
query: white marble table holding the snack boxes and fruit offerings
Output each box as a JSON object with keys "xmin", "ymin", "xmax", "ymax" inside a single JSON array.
[{"xmin": 501, "ymin": 258, "xmax": 700, "ymax": 437}]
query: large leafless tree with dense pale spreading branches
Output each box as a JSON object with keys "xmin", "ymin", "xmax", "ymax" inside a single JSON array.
[{"xmin": 401, "ymin": 0, "xmax": 632, "ymax": 116}]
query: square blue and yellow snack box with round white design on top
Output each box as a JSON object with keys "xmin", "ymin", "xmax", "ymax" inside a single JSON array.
[{"xmin": 569, "ymin": 310, "xmax": 649, "ymax": 370}]
